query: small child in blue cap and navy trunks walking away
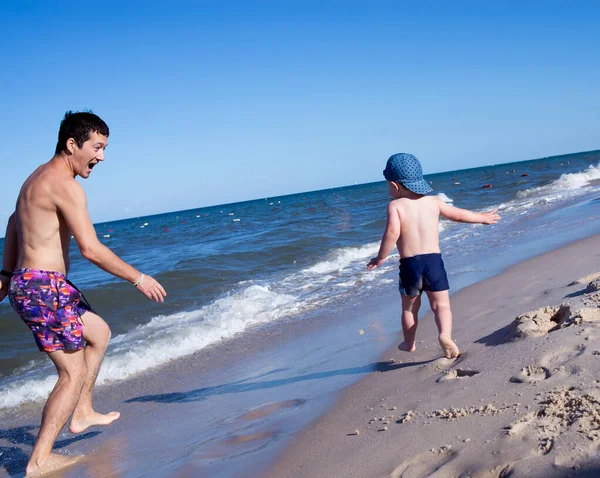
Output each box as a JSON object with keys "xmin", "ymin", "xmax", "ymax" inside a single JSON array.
[{"xmin": 367, "ymin": 153, "xmax": 500, "ymax": 358}]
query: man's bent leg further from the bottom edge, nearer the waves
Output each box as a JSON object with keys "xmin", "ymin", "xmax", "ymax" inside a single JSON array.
[{"xmin": 69, "ymin": 312, "xmax": 121, "ymax": 433}]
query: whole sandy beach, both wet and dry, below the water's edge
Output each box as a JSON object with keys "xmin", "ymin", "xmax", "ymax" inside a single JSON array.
[{"xmin": 0, "ymin": 231, "xmax": 600, "ymax": 477}]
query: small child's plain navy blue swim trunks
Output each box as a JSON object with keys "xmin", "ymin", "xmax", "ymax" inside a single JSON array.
[{"xmin": 400, "ymin": 253, "xmax": 450, "ymax": 297}]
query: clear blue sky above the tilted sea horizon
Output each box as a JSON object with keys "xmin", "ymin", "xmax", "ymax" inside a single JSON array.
[{"xmin": 0, "ymin": 0, "xmax": 600, "ymax": 232}]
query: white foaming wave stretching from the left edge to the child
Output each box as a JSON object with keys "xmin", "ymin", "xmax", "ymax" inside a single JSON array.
[{"xmin": 0, "ymin": 243, "xmax": 384, "ymax": 408}]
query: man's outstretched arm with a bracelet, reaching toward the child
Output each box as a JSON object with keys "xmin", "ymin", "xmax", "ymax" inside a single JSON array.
[{"xmin": 57, "ymin": 180, "xmax": 167, "ymax": 302}]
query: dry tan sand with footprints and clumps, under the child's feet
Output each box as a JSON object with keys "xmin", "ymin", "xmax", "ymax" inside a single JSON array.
[{"xmin": 268, "ymin": 236, "xmax": 600, "ymax": 478}]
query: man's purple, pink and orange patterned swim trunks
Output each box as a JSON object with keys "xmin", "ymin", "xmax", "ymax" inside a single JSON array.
[{"xmin": 8, "ymin": 269, "xmax": 92, "ymax": 352}]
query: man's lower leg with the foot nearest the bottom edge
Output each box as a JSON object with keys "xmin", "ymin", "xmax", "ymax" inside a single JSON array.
[{"xmin": 26, "ymin": 350, "xmax": 87, "ymax": 475}]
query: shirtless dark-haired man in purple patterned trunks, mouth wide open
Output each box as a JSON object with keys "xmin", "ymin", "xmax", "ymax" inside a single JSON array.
[{"xmin": 0, "ymin": 111, "xmax": 166, "ymax": 475}]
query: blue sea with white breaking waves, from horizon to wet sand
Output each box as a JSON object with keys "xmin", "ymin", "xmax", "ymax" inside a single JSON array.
[{"xmin": 0, "ymin": 151, "xmax": 600, "ymax": 411}]
